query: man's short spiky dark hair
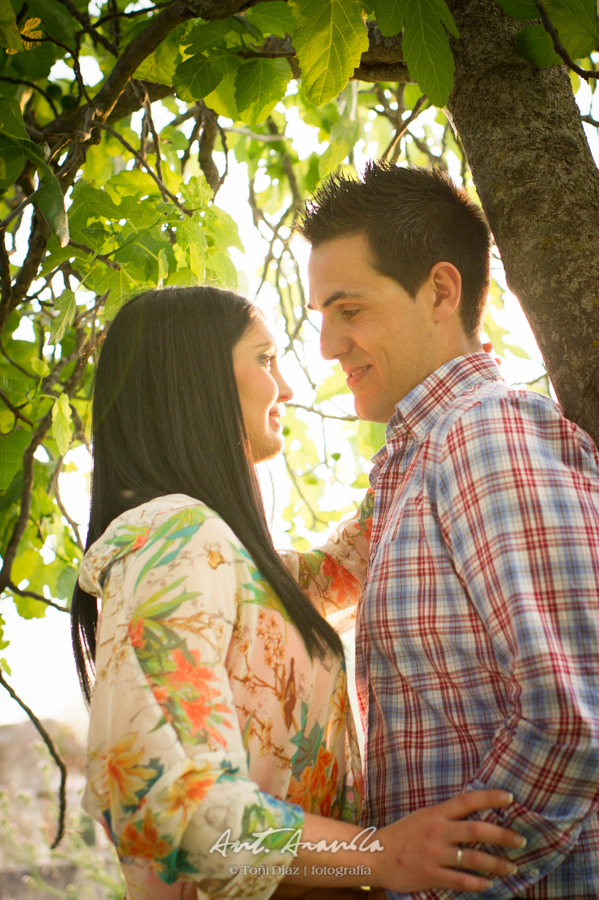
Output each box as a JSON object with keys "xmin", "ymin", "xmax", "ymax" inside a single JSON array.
[{"xmin": 298, "ymin": 162, "xmax": 491, "ymax": 337}]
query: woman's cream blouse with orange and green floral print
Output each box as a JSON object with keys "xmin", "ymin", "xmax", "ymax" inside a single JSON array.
[{"xmin": 79, "ymin": 495, "xmax": 368, "ymax": 900}]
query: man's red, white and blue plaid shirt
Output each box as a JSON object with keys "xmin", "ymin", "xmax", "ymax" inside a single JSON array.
[{"xmin": 356, "ymin": 353, "xmax": 599, "ymax": 900}]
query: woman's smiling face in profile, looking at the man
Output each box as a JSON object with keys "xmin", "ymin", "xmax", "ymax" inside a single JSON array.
[{"xmin": 233, "ymin": 318, "xmax": 293, "ymax": 462}]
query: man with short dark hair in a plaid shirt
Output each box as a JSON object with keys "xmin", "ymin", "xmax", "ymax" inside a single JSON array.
[{"xmin": 300, "ymin": 164, "xmax": 599, "ymax": 900}]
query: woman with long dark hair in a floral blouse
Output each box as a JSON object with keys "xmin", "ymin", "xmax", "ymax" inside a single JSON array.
[{"xmin": 72, "ymin": 287, "xmax": 519, "ymax": 900}]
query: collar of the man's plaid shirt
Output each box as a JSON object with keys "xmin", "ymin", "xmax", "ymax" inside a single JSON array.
[{"xmin": 386, "ymin": 352, "xmax": 503, "ymax": 442}]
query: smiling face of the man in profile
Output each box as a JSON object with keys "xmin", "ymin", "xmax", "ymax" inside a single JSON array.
[{"xmin": 308, "ymin": 235, "xmax": 436, "ymax": 422}]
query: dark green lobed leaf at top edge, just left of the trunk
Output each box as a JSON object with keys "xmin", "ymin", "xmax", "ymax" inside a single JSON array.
[{"xmin": 375, "ymin": 0, "xmax": 460, "ymax": 106}]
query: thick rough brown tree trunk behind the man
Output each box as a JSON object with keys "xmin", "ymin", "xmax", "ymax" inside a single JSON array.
[{"xmin": 448, "ymin": 0, "xmax": 599, "ymax": 444}]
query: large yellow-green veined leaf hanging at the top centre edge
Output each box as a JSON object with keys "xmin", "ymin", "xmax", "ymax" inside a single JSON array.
[{"xmin": 289, "ymin": 0, "xmax": 368, "ymax": 106}]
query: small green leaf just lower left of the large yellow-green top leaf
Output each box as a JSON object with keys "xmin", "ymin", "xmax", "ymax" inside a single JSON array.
[{"xmin": 235, "ymin": 59, "xmax": 291, "ymax": 125}]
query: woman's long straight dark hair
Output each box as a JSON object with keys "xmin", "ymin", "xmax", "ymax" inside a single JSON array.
[{"xmin": 71, "ymin": 287, "xmax": 343, "ymax": 702}]
